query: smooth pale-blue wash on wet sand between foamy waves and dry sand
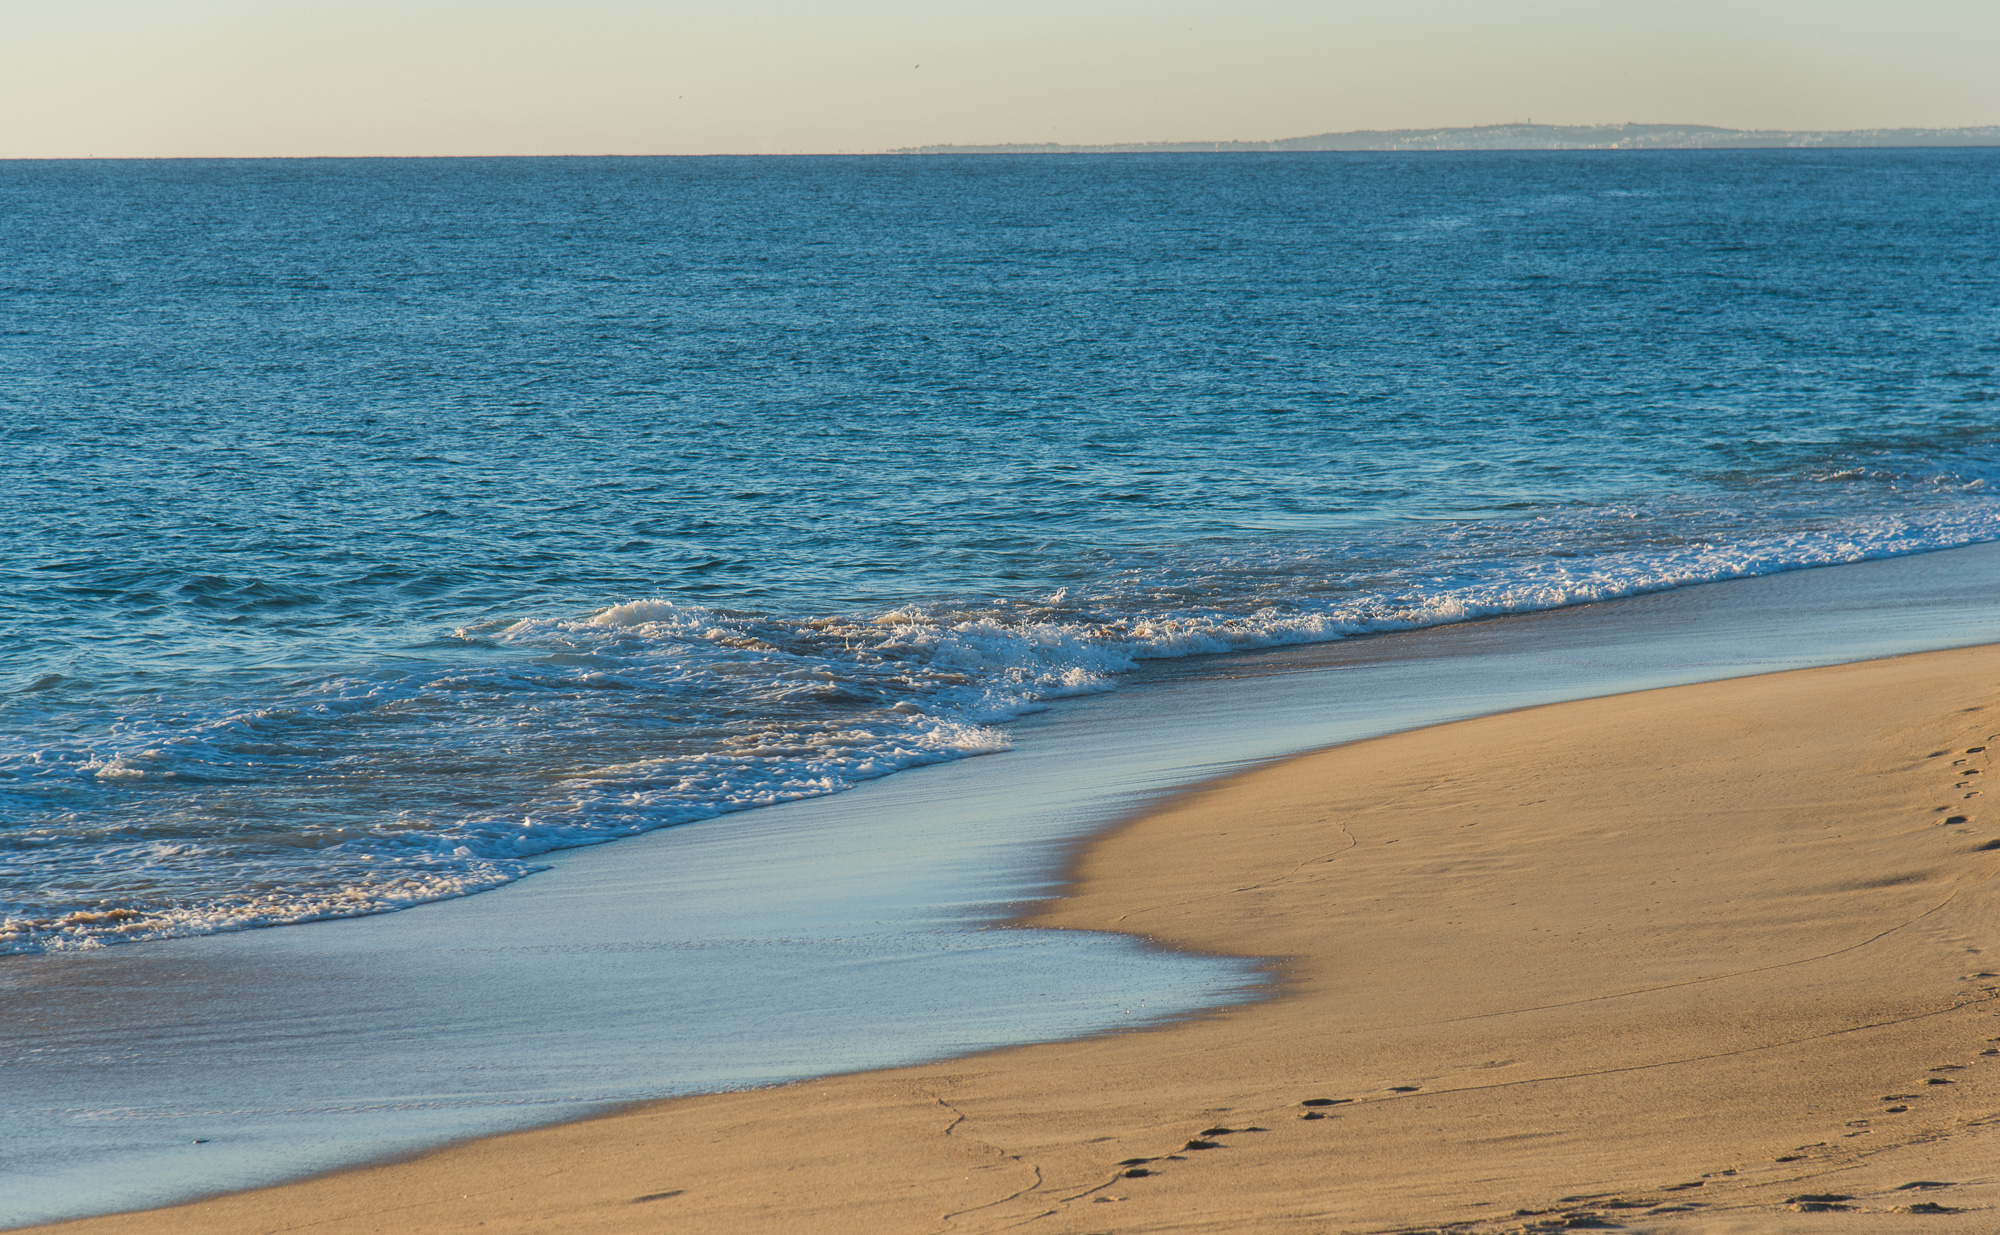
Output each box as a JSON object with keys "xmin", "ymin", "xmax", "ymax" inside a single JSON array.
[{"xmin": 11, "ymin": 546, "xmax": 2000, "ymax": 1221}]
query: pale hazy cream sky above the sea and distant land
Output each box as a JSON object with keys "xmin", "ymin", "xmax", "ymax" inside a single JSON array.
[{"xmin": 0, "ymin": 0, "xmax": 2000, "ymax": 158}]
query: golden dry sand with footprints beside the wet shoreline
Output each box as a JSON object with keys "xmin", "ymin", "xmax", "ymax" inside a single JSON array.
[{"xmin": 23, "ymin": 647, "xmax": 2000, "ymax": 1235}]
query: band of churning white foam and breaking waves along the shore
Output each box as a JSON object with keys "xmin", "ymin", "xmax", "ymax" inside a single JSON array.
[{"xmin": 11, "ymin": 471, "xmax": 2000, "ymax": 951}]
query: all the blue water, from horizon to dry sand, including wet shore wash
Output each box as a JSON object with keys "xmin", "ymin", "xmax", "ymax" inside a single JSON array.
[{"xmin": 0, "ymin": 150, "xmax": 2000, "ymax": 1223}]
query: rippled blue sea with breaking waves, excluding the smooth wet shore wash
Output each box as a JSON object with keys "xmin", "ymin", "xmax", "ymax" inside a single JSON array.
[{"xmin": 0, "ymin": 150, "xmax": 2000, "ymax": 951}]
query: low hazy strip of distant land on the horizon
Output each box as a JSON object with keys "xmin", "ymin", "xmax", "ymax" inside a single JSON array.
[{"xmin": 894, "ymin": 124, "xmax": 2000, "ymax": 154}]
